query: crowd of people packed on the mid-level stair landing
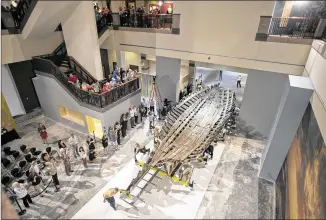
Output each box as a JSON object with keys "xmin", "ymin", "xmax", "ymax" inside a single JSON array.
[{"xmin": 67, "ymin": 68, "xmax": 137, "ymax": 94}]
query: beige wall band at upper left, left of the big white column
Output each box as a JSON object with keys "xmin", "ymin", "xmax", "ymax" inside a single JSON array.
[{"xmin": 1, "ymin": 32, "xmax": 63, "ymax": 64}]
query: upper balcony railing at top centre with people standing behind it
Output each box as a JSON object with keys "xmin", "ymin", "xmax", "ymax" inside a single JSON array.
[{"xmin": 96, "ymin": 13, "xmax": 180, "ymax": 37}]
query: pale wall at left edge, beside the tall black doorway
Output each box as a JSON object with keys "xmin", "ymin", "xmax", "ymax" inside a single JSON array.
[{"xmin": 1, "ymin": 65, "xmax": 26, "ymax": 116}]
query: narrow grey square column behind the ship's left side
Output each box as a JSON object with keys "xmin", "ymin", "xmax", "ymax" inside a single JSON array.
[{"xmin": 156, "ymin": 56, "xmax": 181, "ymax": 102}]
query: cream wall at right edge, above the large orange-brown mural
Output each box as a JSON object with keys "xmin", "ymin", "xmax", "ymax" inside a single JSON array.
[{"xmin": 305, "ymin": 40, "xmax": 326, "ymax": 140}]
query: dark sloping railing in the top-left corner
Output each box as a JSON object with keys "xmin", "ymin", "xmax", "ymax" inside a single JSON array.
[{"xmin": 1, "ymin": 0, "xmax": 38, "ymax": 34}]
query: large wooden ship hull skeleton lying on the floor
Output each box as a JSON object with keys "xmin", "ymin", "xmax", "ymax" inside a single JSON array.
[{"xmin": 124, "ymin": 86, "xmax": 235, "ymax": 195}]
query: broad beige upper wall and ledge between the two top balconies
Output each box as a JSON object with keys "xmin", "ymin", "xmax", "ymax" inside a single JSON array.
[{"xmin": 103, "ymin": 1, "xmax": 310, "ymax": 75}]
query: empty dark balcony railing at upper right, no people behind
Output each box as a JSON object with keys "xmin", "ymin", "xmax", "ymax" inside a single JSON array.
[{"xmin": 268, "ymin": 17, "xmax": 320, "ymax": 38}]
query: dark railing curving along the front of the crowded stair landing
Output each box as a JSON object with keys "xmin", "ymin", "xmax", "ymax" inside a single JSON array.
[{"xmin": 33, "ymin": 57, "xmax": 139, "ymax": 108}]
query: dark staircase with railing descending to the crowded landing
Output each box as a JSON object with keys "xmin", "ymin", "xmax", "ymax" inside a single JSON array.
[{"xmin": 33, "ymin": 42, "xmax": 140, "ymax": 108}]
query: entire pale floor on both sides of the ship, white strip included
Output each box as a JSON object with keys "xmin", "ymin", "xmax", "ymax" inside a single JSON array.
[{"xmin": 2, "ymin": 105, "xmax": 274, "ymax": 219}]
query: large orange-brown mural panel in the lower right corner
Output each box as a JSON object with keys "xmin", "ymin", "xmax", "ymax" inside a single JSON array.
[{"xmin": 275, "ymin": 104, "xmax": 326, "ymax": 219}]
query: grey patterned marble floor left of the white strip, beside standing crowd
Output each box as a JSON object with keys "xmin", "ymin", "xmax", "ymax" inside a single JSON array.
[{"xmin": 3, "ymin": 110, "xmax": 152, "ymax": 219}]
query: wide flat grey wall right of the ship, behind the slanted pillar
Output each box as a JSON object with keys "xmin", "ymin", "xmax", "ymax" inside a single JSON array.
[{"xmin": 240, "ymin": 71, "xmax": 288, "ymax": 137}]
